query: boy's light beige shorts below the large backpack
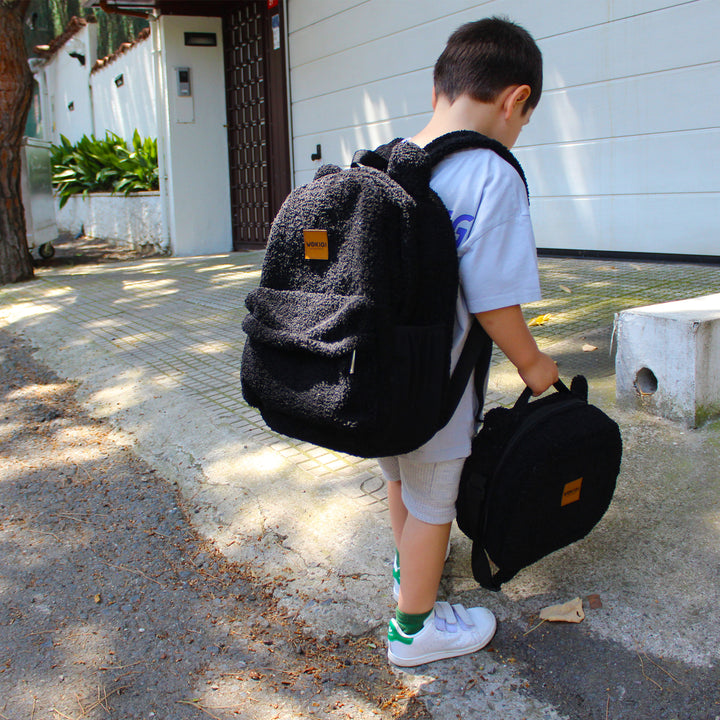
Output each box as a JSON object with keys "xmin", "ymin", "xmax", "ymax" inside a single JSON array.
[{"xmin": 378, "ymin": 455, "xmax": 465, "ymax": 525}]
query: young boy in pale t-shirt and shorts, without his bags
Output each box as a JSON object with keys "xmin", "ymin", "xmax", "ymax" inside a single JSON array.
[{"xmin": 379, "ymin": 18, "xmax": 558, "ymax": 666}]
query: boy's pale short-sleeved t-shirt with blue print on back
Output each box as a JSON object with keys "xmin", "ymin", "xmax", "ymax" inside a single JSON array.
[{"xmin": 408, "ymin": 149, "xmax": 540, "ymax": 463}]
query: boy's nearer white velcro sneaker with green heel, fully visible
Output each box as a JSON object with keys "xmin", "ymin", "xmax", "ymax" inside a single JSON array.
[{"xmin": 388, "ymin": 602, "xmax": 497, "ymax": 667}]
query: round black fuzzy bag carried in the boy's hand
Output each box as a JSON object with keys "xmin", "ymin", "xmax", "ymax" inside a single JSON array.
[{"xmin": 457, "ymin": 375, "xmax": 622, "ymax": 590}]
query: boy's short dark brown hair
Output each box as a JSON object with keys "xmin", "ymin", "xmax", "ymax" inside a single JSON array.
[{"xmin": 434, "ymin": 17, "xmax": 542, "ymax": 111}]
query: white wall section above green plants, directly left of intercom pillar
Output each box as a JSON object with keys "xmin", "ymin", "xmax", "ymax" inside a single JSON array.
[{"xmin": 90, "ymin": 38, "xmax": 158, "ymax": 143}]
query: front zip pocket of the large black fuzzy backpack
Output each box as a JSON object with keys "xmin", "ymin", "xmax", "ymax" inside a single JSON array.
[{"xmin": 241, "ymin": 288, "xmax": 377, "ymax": 437}]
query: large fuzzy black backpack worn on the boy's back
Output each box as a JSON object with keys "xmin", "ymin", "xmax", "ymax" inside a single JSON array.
[{"xmin": 242, "ymin": 138, "xmax": 524, "ymax": 457}]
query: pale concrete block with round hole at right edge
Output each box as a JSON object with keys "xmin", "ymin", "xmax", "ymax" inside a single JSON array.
[{"xmin": 615, "ymin": 294, "xmax": 720, "ymax": 427}]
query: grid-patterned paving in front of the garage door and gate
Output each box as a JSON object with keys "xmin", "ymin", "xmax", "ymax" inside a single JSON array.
[{"xmin": 0, "ymin": 252, "xmax": 720, "ymax": 511}]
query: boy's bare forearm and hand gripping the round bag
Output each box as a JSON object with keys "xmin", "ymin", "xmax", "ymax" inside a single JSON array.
[{"xmin": 475, "ymin": 305, "xmax": 558, "ymax": 395}]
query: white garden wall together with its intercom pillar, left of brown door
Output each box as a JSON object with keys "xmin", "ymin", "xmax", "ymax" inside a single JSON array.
[{"xmin": 38, "ymin": 16, "xmax": 232, "ymax": 255}]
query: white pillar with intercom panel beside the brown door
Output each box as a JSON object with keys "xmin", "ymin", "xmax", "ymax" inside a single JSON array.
[{"xmin": 160, "ymin": 15, "xmax": 232, "ymax": 256}]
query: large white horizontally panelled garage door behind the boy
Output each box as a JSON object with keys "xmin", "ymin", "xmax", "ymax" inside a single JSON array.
[{"xmin": 288, "ymin": 0, "xmax": 720, "ymax": 256}]
